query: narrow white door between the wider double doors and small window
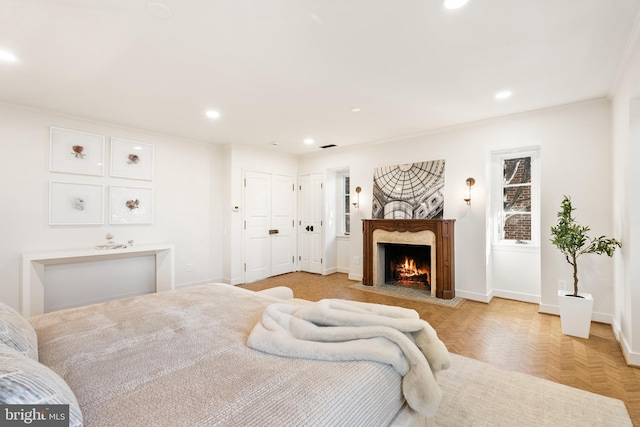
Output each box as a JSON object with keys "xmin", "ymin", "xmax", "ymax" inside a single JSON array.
[{"xmin": 299, "ymin": 174, "xmax": 323, "ymax": 273}]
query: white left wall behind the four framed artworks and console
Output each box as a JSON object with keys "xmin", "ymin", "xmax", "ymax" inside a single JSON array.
[{"xmin": 0, "ymin": 105, "xmax": 222, "ymax": 308}]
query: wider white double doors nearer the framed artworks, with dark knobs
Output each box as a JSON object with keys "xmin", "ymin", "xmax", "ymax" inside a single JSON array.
[{"xmin": 244, "ymin": 171, "xmax": 296, "ymax": 283}]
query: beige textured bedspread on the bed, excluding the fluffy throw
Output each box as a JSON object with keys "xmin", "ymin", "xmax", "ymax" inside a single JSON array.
[{"xmin": 0, "ymin": 284, "xmax": 450, "ymax": 427}]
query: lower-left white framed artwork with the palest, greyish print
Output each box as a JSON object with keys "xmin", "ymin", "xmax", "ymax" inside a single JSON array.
[{"xmin": 49, "ymin": 181, "xmax": 104, "ymax": 225}]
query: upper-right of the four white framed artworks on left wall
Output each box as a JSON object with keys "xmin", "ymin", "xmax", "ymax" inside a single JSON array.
[{"xmin": 111, "ymin": 138, "xmax": 153, "ymax": 181}]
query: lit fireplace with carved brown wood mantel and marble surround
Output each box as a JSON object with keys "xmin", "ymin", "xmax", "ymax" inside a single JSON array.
[{"xmin": 362, "ymin": 219, "xmax": 455, "ymax": 299}]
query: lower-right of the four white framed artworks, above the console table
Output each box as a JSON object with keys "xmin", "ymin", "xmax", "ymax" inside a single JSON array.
[{"xmin": 109, "ymin": 186, "xmax": 153, "ymax": 224}]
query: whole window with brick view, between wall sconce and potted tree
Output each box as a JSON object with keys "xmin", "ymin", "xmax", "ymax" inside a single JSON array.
[{"xmin": 492, "ymin": 149, "xmax": 539, "ymax": 244}]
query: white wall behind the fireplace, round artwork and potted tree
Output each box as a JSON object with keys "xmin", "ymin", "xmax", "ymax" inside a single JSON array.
[{"xmin": 300, "ymin": 99, "xmax": 613, "ymax": 314}]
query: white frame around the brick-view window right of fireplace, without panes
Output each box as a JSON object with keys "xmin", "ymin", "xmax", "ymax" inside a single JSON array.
[{"xmin": 490, "ymin": 147, "xmax": 540, "ymax": 248}]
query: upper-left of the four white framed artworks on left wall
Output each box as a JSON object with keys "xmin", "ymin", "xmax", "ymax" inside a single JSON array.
[{"xmin": 49, "ymin": 127, "xmax": 105, "ymax": 175}]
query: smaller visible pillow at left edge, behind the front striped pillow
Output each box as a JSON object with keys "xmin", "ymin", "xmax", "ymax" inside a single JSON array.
[{"xmin": 0, "ymin": 302, "xmax": 38, "ymax": 362}]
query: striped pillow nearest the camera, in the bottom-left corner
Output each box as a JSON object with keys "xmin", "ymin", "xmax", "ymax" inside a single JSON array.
[{"xmin": 0, "ymin": 344, "xmax": 82, "ymax": 427}]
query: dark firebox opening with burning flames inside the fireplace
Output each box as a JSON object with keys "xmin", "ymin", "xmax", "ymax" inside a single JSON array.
[{"xmin": 384, "ymin": 243, "xmax": 431, "ymax": 290}]
